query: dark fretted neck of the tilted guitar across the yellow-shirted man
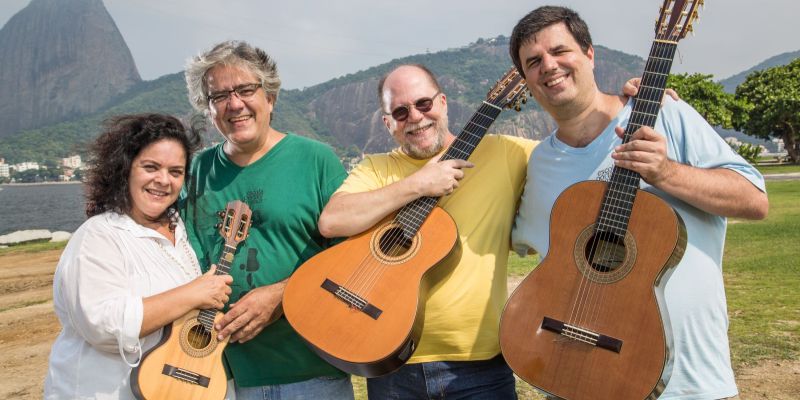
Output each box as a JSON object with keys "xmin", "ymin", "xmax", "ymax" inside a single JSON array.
[{"xmin": 395, "ymin": 101, "xmax": 503, "ymax": 238}]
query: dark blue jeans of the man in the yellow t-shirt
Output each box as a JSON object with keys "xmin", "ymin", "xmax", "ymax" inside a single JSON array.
[{"xmin": 367, "ymin": 355, "xmax": 517, "ymax": 400}]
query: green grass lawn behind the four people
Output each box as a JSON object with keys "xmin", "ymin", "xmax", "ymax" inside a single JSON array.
[{"xmin": 10, "ymin": 181, "xmax": 800, "ymax": 399}]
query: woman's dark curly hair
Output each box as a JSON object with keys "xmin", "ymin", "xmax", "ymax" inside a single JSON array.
[{"xmin": 86, "ymin": 114, "xmax": 201, "ymax": 217}]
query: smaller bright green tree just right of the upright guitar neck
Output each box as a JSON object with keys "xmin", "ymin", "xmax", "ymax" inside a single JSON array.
[{"xmin": 667, "ymin": 74, "xmax": 743, "ymax": 129}]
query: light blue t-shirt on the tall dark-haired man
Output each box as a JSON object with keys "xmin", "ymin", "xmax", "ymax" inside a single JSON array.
[{"xmin": 512, "ymin": 97, "xmax": 765, "ymax": 399}]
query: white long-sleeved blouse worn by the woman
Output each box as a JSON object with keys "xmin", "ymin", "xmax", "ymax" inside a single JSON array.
[{"xmin": 44, "ymin": 212, "xmax": 200, "ymax": 399}]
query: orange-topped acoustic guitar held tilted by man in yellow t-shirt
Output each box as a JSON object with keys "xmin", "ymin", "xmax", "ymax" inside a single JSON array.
[{"xmin": 283, "ymin": 69, "xmax": 526, "ymax": 377}]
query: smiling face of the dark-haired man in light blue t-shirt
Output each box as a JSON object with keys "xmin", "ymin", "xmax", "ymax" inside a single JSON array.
[{"xmin": 519, "ymin": 23, "xmax": 597, "ymax": 114}]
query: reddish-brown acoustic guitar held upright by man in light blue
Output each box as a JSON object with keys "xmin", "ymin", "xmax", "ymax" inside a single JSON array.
[{"xmin": 500, "ymin": 0, "xmax": 702, "ymax": 400}]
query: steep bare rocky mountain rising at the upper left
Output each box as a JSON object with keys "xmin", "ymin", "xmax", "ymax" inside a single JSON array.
[{"xmin": 0, "ymin": 0, "xmax": 141, "ymax": 138}]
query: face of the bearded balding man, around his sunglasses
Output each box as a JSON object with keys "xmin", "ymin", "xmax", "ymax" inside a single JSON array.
[{"xmin": 383, "ymin": 66, "xmax": 454, "ymax": 159}]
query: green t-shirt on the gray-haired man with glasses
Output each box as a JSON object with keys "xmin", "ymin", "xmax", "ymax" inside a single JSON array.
[{"xmin": 181, "ymin": 134, "xmax": 347, "ymax": 387}]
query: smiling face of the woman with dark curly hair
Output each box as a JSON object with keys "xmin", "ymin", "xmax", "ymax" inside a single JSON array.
[{"xmin": 128, "ymin": 139, "xmax": 186, "ymax": 226}]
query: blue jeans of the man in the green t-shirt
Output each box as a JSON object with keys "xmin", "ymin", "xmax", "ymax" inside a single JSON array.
[{"xmin": 236, "ymin": 376, "xmax": 353, "ymax": 400}]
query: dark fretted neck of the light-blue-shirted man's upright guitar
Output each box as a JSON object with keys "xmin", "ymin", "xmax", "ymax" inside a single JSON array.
[{"xmin": 598, "ymin": 40, "xmax": 678, "ymax": 236}]
